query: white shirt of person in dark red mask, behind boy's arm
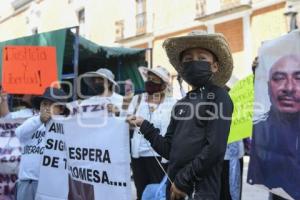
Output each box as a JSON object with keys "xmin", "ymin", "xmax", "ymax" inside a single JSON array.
[{"xmin": 128, "ymin": 93, "xmax": 176, "ymax": 158}]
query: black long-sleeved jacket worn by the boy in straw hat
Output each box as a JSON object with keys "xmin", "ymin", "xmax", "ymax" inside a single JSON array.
[{"xmin": 140, "ymin": 85, "xmax": 233, "ymax": 200}]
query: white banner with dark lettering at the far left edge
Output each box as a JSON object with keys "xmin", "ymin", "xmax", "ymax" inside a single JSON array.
[{"xmin": 0, "ymin": 119, "xmax": 23, "ymax": 200}]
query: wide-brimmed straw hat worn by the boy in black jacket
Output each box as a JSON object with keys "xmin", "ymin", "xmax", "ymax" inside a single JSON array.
[{"xmin": 163, "ymin": 31, "xmax": 233, "ymax": 86}]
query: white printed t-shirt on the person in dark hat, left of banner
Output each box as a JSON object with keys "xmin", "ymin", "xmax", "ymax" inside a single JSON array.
[{"xmin": 16, "ymin": 115, "xmax": 46, "ymax": 180}]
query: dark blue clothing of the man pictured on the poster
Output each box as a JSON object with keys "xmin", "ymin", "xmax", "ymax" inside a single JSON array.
[{"xmin": 248, "ymin": 106, "xmax": 300, "ymax": 199}]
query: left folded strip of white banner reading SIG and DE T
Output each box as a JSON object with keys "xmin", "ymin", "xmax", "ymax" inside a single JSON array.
[{"xmin": 36, "ymin": 117, "xmax": 68, "ymax": 200}]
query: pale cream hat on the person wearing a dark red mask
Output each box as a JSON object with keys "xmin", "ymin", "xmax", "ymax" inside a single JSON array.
[{"xmin": 138, "ymin": 66, "xmax": 171, "ymax": 84}]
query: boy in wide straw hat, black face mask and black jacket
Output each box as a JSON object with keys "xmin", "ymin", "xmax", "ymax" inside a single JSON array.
[{"xmin": 128, "ymin": 31, "xmax": 233, "ymax": 200}]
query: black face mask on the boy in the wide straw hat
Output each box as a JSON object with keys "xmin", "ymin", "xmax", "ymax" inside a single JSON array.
[{"xmin": 181, "ymin": 61, "xmax": 213, "ymax": 87}]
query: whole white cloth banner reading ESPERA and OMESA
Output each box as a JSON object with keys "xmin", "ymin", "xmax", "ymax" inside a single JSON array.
[{"xmin": 36, "ymin": 98, "xmax": 131, "ymax": 200}]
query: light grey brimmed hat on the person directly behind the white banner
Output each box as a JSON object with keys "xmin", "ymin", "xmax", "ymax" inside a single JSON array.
[{"xmin": 83, "ymin": 68, "xmax": 118, "ymax": 87}]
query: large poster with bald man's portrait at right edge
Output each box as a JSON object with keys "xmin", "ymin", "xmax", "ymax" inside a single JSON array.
[{"xmin": 248, "ymin": 31, "xmax": 300, "ymax": 199}]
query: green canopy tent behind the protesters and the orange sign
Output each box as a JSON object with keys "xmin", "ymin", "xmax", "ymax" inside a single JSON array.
[{"xmin": 0, "ymin": 27, "xmax": 147, "ymax": 100}]
